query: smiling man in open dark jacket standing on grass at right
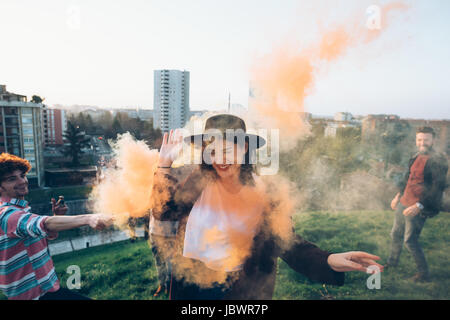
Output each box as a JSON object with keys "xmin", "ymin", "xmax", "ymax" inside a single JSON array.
[{"xmin": 387, "ymin": 127, "xmax": 448, "ymax": 282}]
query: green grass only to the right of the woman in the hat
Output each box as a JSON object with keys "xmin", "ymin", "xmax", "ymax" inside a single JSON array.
[{"xmin": 274, "ymin": 211, "xmax": 450, "ymax": 300}]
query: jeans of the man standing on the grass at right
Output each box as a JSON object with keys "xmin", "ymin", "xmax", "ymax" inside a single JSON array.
[{"xmin": 388, "ymin": 203, "xmax": 428, "ymax": 275}]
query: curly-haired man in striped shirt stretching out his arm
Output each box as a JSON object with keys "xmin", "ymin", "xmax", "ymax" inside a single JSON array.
[{"xmin": 0, "ymin": 153, "xmax": 112, "ymax": 300}]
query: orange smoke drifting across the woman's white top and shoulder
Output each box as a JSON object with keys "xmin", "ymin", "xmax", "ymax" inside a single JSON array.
[{"xmin": 174, "ymin": 177, "xmax": 296, "ymax": 287}]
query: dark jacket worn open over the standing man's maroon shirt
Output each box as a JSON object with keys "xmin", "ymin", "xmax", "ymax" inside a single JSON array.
[{"xmin": 398, "ymin": 150, "xmax": 448, "ymax": 218}]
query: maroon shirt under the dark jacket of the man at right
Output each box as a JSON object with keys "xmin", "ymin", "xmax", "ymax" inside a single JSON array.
[{"xmin": 400, "ymin": 154, "xmax": 429, "ymax": 207}]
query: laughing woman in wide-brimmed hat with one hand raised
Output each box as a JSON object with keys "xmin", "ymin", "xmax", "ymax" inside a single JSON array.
[{"xmin": 153, "ymin": 115, "xmax": 383, "ymax": 300}]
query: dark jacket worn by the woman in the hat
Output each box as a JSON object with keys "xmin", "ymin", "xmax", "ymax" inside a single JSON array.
[{"xmin": 153, "ymin": 166, "xmax": 344, "ymax": 300}]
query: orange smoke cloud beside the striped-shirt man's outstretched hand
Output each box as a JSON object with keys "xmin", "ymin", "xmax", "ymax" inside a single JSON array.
[{"xmin": 91, "ymin": 133, "xmax": 159, "ymax": 226}]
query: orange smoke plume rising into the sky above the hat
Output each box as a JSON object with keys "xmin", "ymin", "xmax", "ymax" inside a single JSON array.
[{"xmin": 249, "ymin": 2, "xmax": 408, "ymax": 146}]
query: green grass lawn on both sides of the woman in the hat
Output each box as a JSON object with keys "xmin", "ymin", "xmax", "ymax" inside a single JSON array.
[{"xmin": 0, "ymin": 211, "xmax": 450, "ymax": 300}]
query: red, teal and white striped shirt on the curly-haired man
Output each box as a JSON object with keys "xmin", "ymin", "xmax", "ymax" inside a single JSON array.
[{"xmin": 0, "ymin": 197, "xmax": 59, "ymax": 300}]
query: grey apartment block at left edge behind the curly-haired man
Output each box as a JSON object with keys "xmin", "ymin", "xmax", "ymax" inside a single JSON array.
[{"xmin": 0, "ymin": 85, "xmax": 44, "ymax": 186}]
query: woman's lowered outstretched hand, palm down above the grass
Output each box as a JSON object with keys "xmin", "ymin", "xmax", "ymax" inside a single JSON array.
[{"xmin": 328, "ymin": 251, "xmax": 384, "ymax": 272}]
